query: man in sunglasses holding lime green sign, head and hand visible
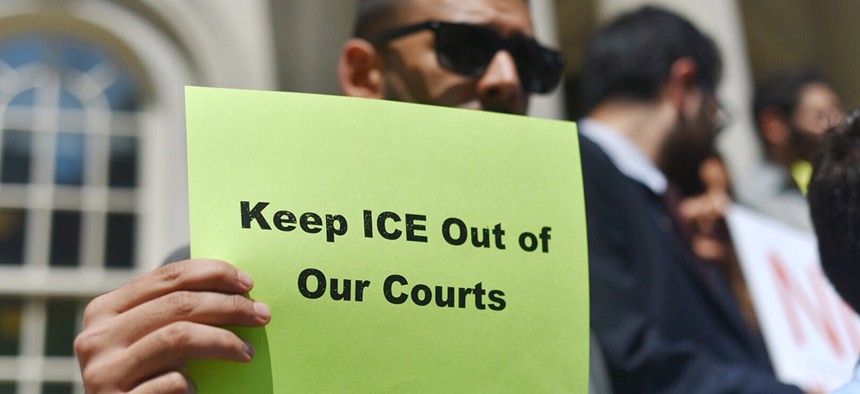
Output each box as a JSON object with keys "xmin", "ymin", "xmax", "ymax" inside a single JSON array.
[{"xmin": 75, "ymin": 0, "xmax": 563, "ymax": 393}]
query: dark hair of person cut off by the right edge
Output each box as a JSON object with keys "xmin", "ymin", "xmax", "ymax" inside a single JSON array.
[{"xmin": 808, "ymin": 109, "xmax": 860, "ymax": 312}]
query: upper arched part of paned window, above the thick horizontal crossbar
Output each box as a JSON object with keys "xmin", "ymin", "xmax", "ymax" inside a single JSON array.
[{"xmin": 0, "ymin": 33, "xmax": 142, "ymax": 268}]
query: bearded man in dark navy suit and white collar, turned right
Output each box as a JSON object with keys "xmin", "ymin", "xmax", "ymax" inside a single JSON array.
[{"xmin": 579, "ymin": 7, "xmax": 801, "ymax": 393}]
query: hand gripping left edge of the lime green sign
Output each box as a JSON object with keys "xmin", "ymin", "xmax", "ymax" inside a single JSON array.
[{"xmin": 75, "ymin": 260, "xmax": 271, "ymax": 393}]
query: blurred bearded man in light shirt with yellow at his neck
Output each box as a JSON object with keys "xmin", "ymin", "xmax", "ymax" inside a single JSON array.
[{"xmin": 735, "ymin": 70, "xmax": 842, "ymax": 232}]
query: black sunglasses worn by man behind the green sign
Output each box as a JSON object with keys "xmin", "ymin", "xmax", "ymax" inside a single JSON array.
[{"xmin": 369, "ymin": 20, "xmax": 565, "ymax": 93}]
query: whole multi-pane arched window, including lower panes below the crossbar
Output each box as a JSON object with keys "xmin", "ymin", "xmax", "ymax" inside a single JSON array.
[{"xmin": 0, "ymin": 31, "xmax": 145, "ymax": 393}]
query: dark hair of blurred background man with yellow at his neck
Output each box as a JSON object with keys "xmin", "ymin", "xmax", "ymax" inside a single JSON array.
[{"xmin": 753, "ymin": 69, "xmax": 832, "ymax": 127}]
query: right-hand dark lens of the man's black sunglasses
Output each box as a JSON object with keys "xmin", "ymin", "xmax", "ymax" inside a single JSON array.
[{"xmin": 511, "ymin": 38, "xmax": 564, "ymax": 93}]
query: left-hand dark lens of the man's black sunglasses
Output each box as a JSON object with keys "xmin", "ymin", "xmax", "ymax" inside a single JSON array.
[{"xmin": 436, "ymin": 24, "xmax": 499, "ymax": 77}]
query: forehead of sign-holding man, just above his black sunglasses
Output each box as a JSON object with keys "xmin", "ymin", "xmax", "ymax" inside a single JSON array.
[{"xmin": 399, "ymin": 0, "xmax": 533, "ymax": 35}]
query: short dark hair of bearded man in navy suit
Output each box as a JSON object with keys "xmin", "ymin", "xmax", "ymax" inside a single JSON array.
[{"xmin": 580, "ymin": 7, "xmax": 722, "ymax": 111}]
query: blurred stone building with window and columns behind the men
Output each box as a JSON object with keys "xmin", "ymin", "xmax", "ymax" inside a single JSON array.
[{"xmin": 0, "ymin": 0, "xmax": 860, "ymax": 394}]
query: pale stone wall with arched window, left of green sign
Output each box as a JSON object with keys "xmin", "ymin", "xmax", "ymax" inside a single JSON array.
[{"xmin": 0, "ymin": 0, "xmax": 276, "ymax": 394}]
